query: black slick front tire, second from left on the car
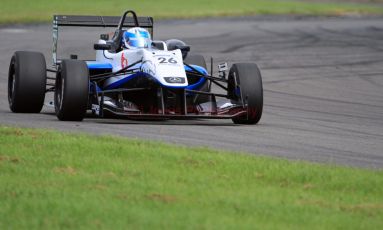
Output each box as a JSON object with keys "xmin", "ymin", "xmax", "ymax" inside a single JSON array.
[{"xmin": 54, "ymin": 60, "xmax": 89, "ymax": 121}]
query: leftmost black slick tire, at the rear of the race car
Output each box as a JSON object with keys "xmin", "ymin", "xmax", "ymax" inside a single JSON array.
[{"xmin": 8, "ymin": 51, "xmax": 47, "ymax": 113}]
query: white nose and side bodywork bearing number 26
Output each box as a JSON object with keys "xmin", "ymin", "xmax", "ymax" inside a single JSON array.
[{"xmin": 96, "ymin": 40, "xmax": 188, "ymax": 87}]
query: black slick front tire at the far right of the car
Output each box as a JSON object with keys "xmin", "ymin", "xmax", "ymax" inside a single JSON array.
[{"xmin": 228, "ymin": 63, "xmax": 263, "ymax": 124}]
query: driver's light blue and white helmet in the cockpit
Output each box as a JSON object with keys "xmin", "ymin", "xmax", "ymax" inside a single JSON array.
[{"xmin": 122, "ymin": 27, "xmax": 152, "ymax": 49}]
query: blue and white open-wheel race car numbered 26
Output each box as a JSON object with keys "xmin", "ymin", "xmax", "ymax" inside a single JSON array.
[{"xmin": 8, "ymin": 10, "xmax": 263, "ymax": 124}]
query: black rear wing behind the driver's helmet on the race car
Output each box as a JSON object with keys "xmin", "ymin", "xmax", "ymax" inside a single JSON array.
[{"xmin": 52, "ymin": 15, "xmax": 153, "ymax": 66}]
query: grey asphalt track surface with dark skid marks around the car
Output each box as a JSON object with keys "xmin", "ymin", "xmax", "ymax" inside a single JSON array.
[{"xmin": 0, "ymin": 17, "xmax": 383, "ymax": 168}]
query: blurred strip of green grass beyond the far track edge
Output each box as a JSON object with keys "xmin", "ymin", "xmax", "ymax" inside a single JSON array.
[{"xmin": 0, "ymin": 0, "xmax": 383, "ymax": 24}]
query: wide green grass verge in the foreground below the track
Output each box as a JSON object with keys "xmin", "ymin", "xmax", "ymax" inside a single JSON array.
[{"xmin": 0, "ymin": 126, "xmax": 383, "ymax": 229}]
